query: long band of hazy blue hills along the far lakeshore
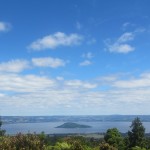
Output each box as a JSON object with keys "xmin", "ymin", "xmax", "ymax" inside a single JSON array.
[{"xmin": 1, "ymin": 115, "xmax": 150, "ymax": 124}]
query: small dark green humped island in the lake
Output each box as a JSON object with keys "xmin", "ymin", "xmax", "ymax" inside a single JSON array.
[{"xmin": 56, "ymin": 122, "xmax": 91, "ymax": 128}]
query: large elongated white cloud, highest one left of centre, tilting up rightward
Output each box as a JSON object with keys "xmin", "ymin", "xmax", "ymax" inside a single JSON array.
[{"xmin": 29, "ymin": 32, "xmax": 83, "ymax": 50}]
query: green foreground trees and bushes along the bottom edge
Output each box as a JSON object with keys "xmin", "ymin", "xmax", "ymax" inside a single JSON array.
[{"xmin": 0, "ymin": 118, "xmax": 150, "ymax": 150}]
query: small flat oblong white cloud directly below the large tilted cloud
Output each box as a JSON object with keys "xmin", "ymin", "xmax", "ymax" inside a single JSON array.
[{"xmin": 32, "ymin": 57, "xmax": 66, "ymax": 68}]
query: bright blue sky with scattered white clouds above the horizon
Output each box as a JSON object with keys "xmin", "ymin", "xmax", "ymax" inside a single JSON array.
[{"xmin": 0, "ymin": 0, "xmax": 150, "ymax": 116}]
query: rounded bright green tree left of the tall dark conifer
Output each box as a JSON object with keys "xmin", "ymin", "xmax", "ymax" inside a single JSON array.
[{"xmin": 104, "ymin": 128, "xmax": 125, "ymax": 150}]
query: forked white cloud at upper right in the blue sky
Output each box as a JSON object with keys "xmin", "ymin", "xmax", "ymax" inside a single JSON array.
[{"xmin": 106, "ymin": 32, "xmax": 135, "ymax": 54}]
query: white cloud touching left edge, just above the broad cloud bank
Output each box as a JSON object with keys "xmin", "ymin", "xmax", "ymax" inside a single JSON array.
[{"xmin": 0, "ymin": 59, "xmax": 30, "ymax": 72}]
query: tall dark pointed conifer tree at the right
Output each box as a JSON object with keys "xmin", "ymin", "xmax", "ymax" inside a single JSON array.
[{"xmin": 128, "ymin": 117, "xmax": 145, "ymax": 147}]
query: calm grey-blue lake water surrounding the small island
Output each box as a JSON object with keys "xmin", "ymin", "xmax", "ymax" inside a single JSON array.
[{"xmin": 3, "ymin": 122, "xmax": 150, "ymax": 134}]
